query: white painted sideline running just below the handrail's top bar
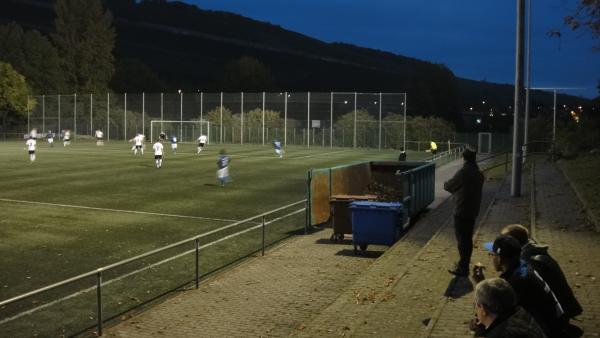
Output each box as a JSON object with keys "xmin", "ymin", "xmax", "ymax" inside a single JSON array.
[{"xmin": 0, "ymin": 208, "xmax": 305, "ymax": 325}]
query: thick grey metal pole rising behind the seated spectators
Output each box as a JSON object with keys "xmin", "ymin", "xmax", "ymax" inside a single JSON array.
[{"xmin": 510, "ymin": 0, "xmax": 525, "ymax": 197}]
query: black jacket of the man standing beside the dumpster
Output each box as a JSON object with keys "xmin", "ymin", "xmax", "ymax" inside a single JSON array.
[{"xmin": 444, "ymin": 161, "xmax": 483, "ymax": 219}]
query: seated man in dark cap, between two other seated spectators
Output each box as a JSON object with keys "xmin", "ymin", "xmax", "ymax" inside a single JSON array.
[{"xmin": 484, "ymin": 236, "xmax": 565, "ymax": 337}]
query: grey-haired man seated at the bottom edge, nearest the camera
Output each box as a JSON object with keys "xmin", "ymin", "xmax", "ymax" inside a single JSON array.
[{"xmin": 473, "ymin": 278, "xmax": 546, "ymax": 338}]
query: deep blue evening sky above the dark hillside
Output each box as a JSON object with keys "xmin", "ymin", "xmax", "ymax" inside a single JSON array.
[{"xmin": 185, "ymin": 0, "xmax": 600, "ymax": 97}]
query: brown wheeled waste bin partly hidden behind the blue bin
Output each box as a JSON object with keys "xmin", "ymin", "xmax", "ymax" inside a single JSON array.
[{"xmin": 329, "ymin": 194, "xmax": 377, "ymax": 241}]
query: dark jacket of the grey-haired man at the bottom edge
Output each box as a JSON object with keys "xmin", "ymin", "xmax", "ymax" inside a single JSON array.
[{"xmin": 481, "ymin": 306, "xmax": 546, "ymax": 338}]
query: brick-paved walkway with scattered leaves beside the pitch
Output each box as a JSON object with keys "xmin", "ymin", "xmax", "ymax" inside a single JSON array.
[{"xmin": 105, "ymin": 157, "xmax": 600, "ymax": 337}]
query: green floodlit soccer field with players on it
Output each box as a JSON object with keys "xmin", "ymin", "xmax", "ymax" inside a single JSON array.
[{"xmin": 0, "ymin": 141, "xmax": 427, "ymax": 336}]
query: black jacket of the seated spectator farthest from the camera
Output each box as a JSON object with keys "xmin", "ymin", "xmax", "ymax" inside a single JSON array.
[{"xmin": 521, "ymin": 241, "xmax": 583, "ymax": 318}]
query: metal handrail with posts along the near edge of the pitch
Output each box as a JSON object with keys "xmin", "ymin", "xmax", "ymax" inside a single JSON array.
[{"xmin": 0, "ymin": 199, "xmax": 307, "ymax": 335}]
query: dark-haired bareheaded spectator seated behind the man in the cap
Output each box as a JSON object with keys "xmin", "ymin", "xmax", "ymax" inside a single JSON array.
[{"xmin": 500, "ymin": 224, "xmax": 583, "ymax": 322}]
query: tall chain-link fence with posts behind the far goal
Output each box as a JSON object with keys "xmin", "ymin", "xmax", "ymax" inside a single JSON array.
[{"xmin": 24, "ymin": 92, "xmax": 406, "ymax": 148}]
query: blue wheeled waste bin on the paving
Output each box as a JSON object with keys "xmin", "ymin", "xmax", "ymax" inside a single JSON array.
[{"xmin": 350, "ymin": 201, "xmax": 404, "ymax": 253}]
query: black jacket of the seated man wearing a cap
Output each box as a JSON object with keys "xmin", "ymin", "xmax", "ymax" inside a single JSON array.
[{"xmin": 500, "ymin": 261, "xmax": 565, "ymax": 337}]
